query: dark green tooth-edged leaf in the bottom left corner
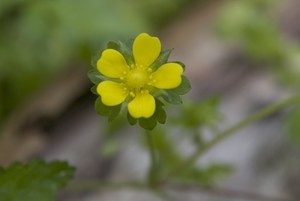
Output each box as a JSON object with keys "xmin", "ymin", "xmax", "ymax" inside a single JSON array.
[{"xmin": 0, "ymin": 160, "xmax": 74, "ymax": 201}]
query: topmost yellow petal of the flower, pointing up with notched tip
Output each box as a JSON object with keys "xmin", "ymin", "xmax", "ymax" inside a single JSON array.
[{"xmin": 133, "ymin": 33, "xmax": 161, "ymax": 67}]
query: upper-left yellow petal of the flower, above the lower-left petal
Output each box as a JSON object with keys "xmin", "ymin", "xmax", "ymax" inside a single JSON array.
[{"xmin": 97, "ymin": 49, "xmax": 129, "ymax": 78}]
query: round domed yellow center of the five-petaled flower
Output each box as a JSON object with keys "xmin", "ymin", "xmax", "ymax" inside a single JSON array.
[{"xmin": 125, "ymin": 69, "xmax": 149, "ymax": 88}]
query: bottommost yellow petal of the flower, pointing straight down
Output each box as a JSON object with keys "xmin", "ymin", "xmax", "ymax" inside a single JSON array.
[{"xmin": 128, "ymin": 92, "xmax": 155, "ymax": 119}]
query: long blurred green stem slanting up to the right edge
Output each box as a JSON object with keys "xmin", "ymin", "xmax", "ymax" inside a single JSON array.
[{"xmin": 162, "ymin": 94, "xmax": 300, "ymax": 183}]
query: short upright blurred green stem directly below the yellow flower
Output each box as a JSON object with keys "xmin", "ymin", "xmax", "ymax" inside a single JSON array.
[{"xmin": 146, "ymin": 131, "xmax": 158, "ymax": 188}]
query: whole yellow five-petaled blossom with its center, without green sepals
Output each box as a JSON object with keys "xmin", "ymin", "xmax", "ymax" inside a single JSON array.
[{"xmin": 97, "ymin": 33, "xmax": 183, "ymax": 118}]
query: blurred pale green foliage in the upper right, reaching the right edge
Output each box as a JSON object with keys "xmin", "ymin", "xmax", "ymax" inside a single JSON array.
[{"xmin": 217, "ymin": 0, "xmax": 300, "ymax": 89}]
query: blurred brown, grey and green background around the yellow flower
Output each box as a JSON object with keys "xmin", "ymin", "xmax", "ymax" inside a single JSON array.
[{"xmin": 0, "ymin": 0, "xmax": 300, "ymax": 201}]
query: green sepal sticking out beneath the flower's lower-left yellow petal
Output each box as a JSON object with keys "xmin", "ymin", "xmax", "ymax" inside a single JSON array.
[{"xmin": 95, "ymin": 97, "xmax": 121, "ymax": 121}]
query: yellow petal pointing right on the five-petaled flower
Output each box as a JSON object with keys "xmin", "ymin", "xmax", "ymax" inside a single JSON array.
[{"xmin": 152, "ymin": 63, "xmax": 183, "ymax": 89}]
